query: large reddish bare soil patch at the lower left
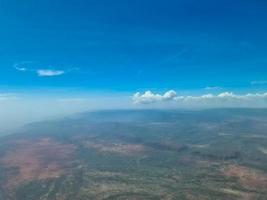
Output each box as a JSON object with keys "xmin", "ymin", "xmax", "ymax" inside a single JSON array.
[{"xmin": 1, "ymin": 138, "xmax": 75, "ymax": 186}]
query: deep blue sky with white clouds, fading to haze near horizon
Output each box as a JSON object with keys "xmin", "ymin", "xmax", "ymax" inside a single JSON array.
[{"xmin": 0, "ymin": 0, "xmax": 267, "ymax": 133}]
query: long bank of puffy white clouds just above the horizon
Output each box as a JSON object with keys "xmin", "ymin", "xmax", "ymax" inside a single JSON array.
[{"xmin": 132, "ymin": 90, "xmax": 267, "ymax": 107}]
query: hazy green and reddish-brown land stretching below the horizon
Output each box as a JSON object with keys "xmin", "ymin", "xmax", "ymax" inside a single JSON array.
[{"xmin": 0, "ymin": 109, "xmax": 267, "ymax": 200}]
